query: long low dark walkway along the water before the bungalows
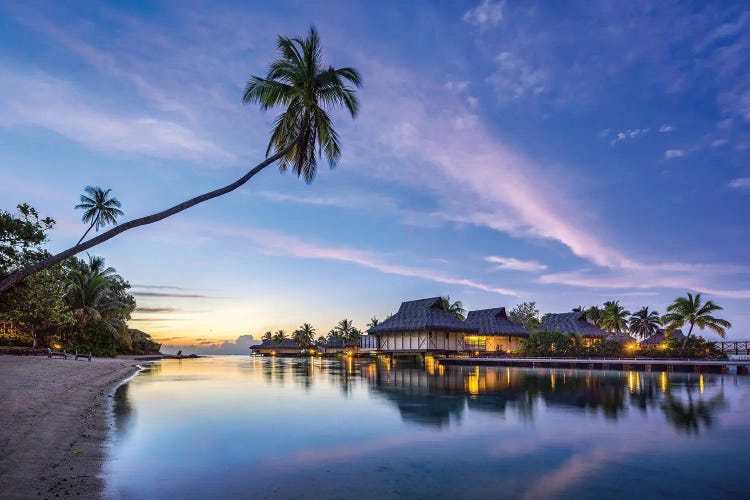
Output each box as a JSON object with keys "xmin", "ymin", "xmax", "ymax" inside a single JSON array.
[{"xmin": 440, "ymin": 357, "xmax": 750, "ymax": 374}]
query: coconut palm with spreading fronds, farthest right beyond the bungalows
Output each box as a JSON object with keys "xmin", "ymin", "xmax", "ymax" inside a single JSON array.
[{"xmin": 661, "ymin": 293, "xmax": 732, "ymax": 356}]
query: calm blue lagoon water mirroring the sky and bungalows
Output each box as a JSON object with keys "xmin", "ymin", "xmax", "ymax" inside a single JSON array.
[{"xmin": 105, "ymin": 356, "xmax": 750, "ymax": 499}]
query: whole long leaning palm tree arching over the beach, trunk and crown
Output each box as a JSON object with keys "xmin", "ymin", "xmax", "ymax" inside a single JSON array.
[{"xmin": 0, "ymin": 27, "xmax": 362, "ymax": 293}]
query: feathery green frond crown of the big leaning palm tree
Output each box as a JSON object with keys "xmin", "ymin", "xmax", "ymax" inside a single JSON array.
[{"xmin": 242, "ymin": 26, "xmax": 362, "ymax": 183}]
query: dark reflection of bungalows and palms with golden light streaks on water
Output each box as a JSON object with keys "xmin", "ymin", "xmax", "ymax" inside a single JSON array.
[{"xmin": 360, "ymin": 359, "xmax": 726, "ymax": 433}]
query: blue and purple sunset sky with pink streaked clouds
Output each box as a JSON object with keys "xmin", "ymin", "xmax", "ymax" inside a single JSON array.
[{"xmin": 0, "ymin": 0, "xmax": 750, "ymax": 352}]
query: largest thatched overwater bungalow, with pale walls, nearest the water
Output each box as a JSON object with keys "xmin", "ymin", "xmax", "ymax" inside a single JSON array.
[{"xmin": 368, "ymin": 297, "xmax": 478, "ymax": 354}]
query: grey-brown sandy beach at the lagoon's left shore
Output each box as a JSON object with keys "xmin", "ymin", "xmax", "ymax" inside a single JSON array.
[{"xmin": 0, "ymin": 356, "xmax": 137, "ymax": 499}]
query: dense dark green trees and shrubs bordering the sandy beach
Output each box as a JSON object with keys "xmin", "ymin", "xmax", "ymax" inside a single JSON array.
[{"xmin": 0, "ymin": 204, "xmax": 160, "ymax": 355}]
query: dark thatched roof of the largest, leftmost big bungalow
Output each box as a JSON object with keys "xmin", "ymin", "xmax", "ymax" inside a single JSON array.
[{"xmin": 368, "ymin": 297, "xmax": 478, "ymax": 334}]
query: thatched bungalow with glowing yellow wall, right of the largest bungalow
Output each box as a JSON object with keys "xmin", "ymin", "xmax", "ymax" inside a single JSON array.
[{"xmin": 465, "ymin": 307, "xmax": 529, "ymax": 352}]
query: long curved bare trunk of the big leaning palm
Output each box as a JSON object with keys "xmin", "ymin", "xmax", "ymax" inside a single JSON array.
[{"xmin": 0, "ymin": 140, "xmax": 297, "ymax": 294}]
